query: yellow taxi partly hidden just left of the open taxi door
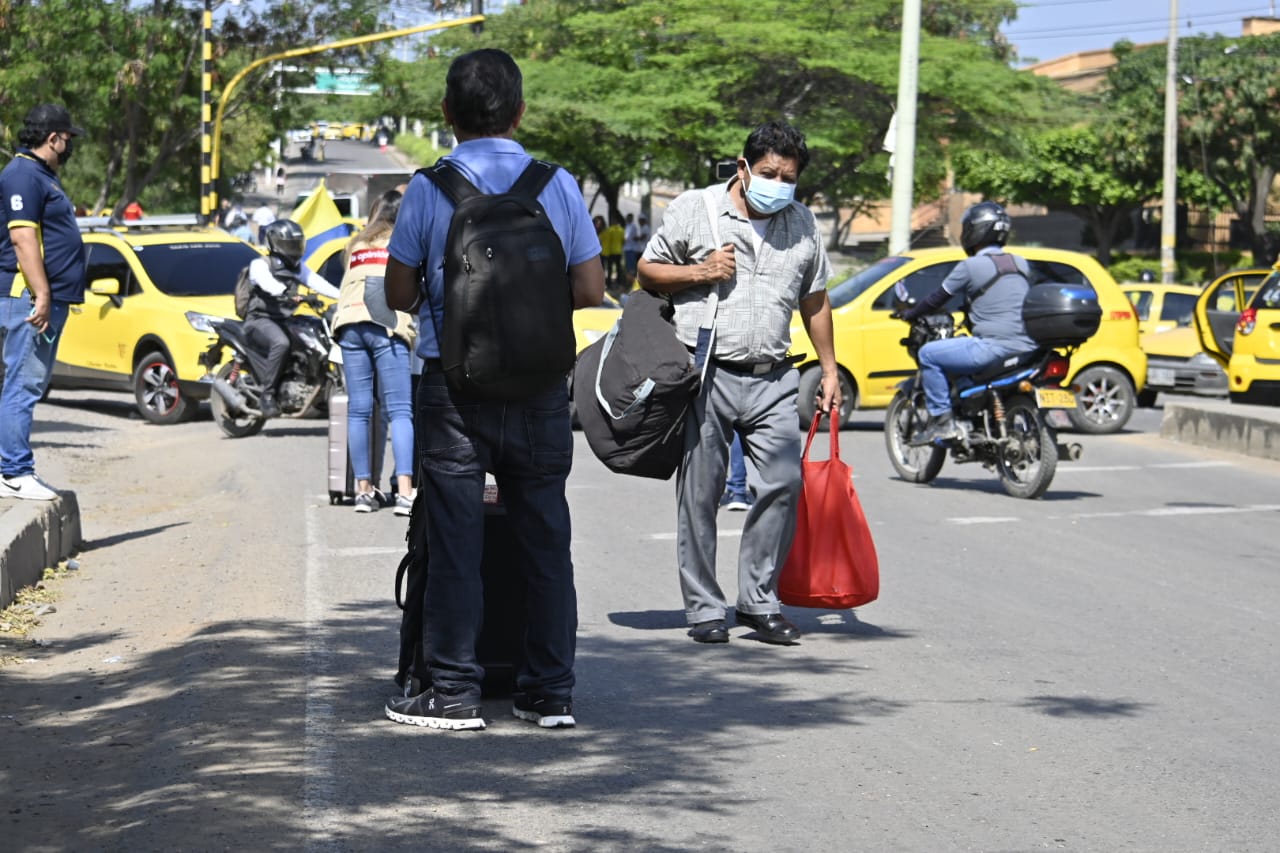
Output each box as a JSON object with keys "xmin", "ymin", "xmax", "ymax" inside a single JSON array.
[{"xmin": 1120, "ymin": 282, "xmax": 1226, "ymax": 406}]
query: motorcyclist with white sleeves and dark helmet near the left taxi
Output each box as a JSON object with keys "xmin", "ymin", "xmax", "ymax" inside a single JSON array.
[{"xmin": 244, "ymin": 219, "xmax": 338, "ymax": 418}]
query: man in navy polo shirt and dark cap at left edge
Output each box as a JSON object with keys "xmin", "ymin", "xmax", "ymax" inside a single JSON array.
[{"xmin": 0, "ymin": 104, "xmax": 84, "ymax": 501}]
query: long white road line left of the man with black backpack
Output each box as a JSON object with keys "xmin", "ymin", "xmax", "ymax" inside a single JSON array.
[{"xmin": 297, "ymin": 502, "xmax": 339, "ymax": 850}]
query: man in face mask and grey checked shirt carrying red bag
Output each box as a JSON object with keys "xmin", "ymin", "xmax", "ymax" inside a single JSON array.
[{"xmin": 639, "ymin": 122, "xmax": 841, "ymax": 646}]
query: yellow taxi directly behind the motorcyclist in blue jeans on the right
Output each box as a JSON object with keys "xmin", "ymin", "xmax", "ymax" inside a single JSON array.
[{"xmin": 791, "ymin": 246, "xmax": 1147, "ymax": 433}]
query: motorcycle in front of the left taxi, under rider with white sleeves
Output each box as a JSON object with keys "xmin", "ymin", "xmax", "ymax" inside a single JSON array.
[{"xmin": 200, "ymin": 296, "xmax": 342, "ymax": 438}]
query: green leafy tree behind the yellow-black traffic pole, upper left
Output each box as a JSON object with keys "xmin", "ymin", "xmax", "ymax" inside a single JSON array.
[{"xmin": 0, "ymin": 0, "xmax": 380, "ymax": 211}]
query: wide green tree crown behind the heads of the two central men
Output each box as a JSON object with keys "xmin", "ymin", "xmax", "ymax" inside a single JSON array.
[{"xmin": 391, "ymin": 0, "xmax": 1059, "ymax": 244}]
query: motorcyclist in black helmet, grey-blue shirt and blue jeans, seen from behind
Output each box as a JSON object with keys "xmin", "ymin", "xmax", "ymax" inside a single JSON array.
[{"xmin": 901, "ymin": 201, "xmax": 1037, "ymax": 444}]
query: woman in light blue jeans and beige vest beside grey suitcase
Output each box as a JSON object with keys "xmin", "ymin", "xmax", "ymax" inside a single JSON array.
[{"xmin": 334, "ymin": 190, "xmax": 416, "ymax": 515}]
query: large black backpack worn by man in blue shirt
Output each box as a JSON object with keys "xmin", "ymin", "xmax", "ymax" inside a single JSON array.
[{"xmin": 417, "ymin": 160, "xmax": 577, "ymax": 400}]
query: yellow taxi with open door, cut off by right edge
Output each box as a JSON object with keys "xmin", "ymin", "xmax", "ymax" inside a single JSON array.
[{"xmin": 1196, "ymin": 264, "xmax": 1280, "ymax": 406}]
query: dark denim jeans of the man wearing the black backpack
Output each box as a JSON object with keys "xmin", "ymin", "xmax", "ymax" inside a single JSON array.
[{"xmin": 415, "ymin": 368, "xmax": 577, "ymax": 699}]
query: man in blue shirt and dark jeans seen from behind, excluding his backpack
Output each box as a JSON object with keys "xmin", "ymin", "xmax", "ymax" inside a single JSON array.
[{"xmin": 385, "ymin": 49, "xmax": 601, "ymax": 729}]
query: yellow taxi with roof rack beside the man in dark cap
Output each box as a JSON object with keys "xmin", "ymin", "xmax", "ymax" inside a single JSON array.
[{"xmin": 50, "ymin": 216, "xmax": 259, "ymax": 424}]
